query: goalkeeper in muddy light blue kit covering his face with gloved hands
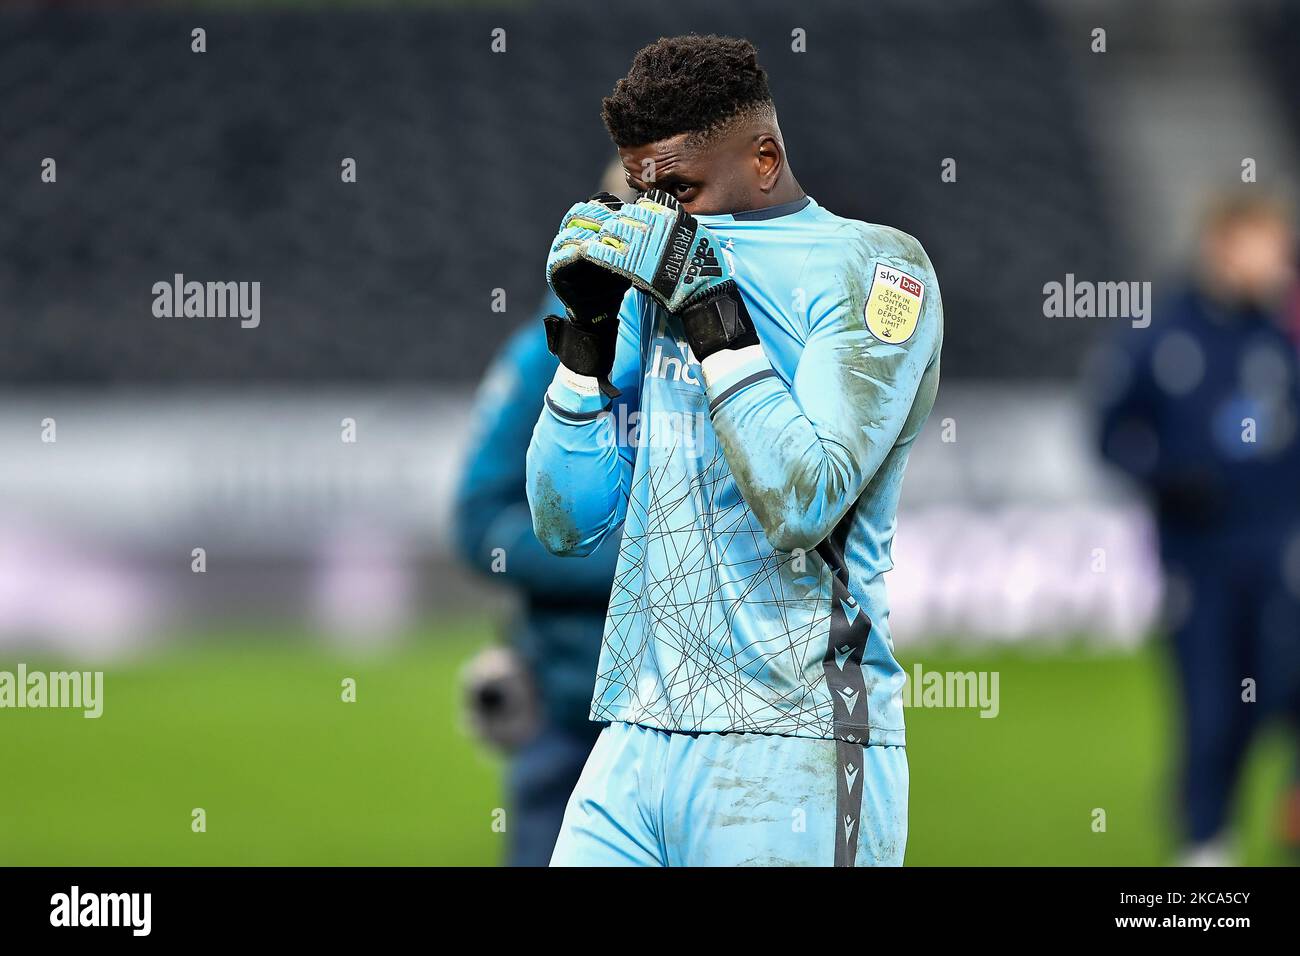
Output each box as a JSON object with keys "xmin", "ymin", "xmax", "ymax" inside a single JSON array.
[{"xmin": 528, "ymin": 36, "xmax": 943, "ymax": 865}]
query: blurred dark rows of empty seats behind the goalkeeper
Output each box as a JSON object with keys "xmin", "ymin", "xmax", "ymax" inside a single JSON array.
[{"xmin": 0, "ymin": 0, "xmax": 1115, "ymax": 384}]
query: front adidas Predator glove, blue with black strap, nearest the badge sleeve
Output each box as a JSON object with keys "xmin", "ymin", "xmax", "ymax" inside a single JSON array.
[{"xmin": 580, "ymin": 190, "xmax": 758, "ymax": 362}]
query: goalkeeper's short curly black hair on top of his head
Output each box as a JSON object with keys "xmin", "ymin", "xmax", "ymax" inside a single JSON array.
[{"xmin": 601, "ymin": 34, "xmax": 772, "ymax": 146}]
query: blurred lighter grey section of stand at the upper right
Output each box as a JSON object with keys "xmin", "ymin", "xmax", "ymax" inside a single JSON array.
[{"xmin": 1049, "ymin": 0, "xmax": 1300, "ymax": 277}]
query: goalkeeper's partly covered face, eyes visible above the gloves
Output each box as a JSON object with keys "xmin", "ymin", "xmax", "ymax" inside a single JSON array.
[{"xmin": 619, "ymin": 133, "xmax": 764, "ymax": 216}]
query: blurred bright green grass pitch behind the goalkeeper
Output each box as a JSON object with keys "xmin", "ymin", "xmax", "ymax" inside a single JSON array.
[{"xmin": 0, "ymin": 620, "xmax": 1290, "ymax": 866}]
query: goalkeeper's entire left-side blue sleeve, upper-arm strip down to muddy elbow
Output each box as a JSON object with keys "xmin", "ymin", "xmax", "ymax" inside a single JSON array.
[{"xmin": 528, "ymin": 290, "xmax": 641, "ymax": 557}]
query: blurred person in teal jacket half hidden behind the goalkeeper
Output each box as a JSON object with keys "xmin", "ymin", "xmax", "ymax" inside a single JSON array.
[{"xmin": 455, "ymin": 161, "xmax": 634, "ymax": 866}]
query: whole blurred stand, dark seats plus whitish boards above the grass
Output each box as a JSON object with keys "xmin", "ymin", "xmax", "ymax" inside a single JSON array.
[{"xmin": 10, "ymin": 0, "xmax": 1300, "ymax": 645}]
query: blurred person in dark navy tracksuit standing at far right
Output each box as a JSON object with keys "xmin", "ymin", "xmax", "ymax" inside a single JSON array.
[{"xmin": 1101, "ymin": 195, "xmax": 1300, "ymax": 865}]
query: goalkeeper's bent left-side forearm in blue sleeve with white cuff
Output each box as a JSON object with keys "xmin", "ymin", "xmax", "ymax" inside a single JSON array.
[{"xmin": 528, "ymin": 368, "xmax": 631, "ymax": 557}]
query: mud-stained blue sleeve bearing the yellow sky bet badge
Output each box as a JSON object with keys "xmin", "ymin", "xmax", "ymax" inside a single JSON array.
[{"xmin": 703, "ymin": 230, "xmax": 943, "ymax": 551}]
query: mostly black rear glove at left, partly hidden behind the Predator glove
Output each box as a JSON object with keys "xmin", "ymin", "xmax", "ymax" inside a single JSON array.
[{"xmin": 543, "ymin": 193, "xmax": 629, "ymax": 398}]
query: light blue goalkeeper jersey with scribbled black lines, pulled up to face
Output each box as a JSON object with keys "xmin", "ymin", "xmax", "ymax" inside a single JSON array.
[{"xmin": 528, "ymin": 198, "xmax": 943, "ymax": 745}]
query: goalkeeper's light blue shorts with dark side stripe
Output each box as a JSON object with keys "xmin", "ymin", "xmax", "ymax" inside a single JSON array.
[{"xmin": 551, "ymin": 723, "xmax": 907, "ymax": 866}]
